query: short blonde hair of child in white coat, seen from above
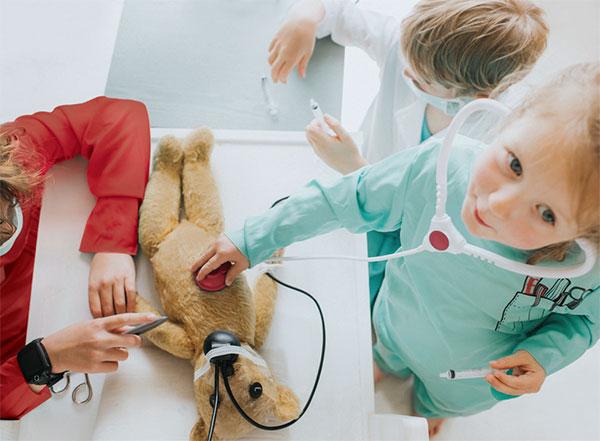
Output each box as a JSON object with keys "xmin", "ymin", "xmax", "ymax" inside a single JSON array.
[{"xmin": 401, "ymin": 0, "xmax": 548, "ymax": 96}]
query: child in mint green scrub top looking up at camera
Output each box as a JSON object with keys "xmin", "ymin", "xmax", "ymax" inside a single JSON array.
[{"xmin": 194, "ymin": 63, "xmax": 600, "ymax": 434}]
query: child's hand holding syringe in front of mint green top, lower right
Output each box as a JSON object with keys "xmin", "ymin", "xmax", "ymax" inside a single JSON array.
[{"xmin": 485, "ymin": 350, "xmax": 546, "ymax": 395}]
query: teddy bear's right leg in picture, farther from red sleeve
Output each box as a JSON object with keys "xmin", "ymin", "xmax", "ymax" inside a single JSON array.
[{"xmin": 183, "ymin": 128, "xmax": 223, "ymax": 236}]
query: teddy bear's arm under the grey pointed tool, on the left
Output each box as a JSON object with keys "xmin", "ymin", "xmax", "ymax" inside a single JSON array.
[{"xmin": 135, "ymin": 295, "xmax": 194, "ymax": 360}]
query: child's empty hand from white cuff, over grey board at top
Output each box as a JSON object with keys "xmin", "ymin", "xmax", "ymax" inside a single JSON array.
[{"xmin": 269, "ymin": 0, "xmax": 325, "ymax": 83}]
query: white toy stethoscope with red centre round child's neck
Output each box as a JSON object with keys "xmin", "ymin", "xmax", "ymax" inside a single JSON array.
[{"xmin": 265, "ymin": 98, "xmax": 597, "ymax": 279}]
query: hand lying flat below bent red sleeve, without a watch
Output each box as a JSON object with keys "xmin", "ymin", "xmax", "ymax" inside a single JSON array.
[{"xmin": 88, "ymin": 253, "xmax": 137, "ymax": 318}]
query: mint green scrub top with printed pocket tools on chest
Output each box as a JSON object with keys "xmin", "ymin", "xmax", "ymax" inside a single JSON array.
[{"xmin": 227, "ymin": 137, "xmax": 600, "ymax": 417}]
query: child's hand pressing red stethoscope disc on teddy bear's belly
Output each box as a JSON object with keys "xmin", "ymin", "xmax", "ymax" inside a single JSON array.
[{"xmin": 192, "ymin": 234, "xmax": 250, "ymax": 286}]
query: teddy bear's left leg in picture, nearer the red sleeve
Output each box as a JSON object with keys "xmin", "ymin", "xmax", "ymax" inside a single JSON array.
[{"xmin": 139, "ymin": 136, "xmax": 183, "ymax": 257}]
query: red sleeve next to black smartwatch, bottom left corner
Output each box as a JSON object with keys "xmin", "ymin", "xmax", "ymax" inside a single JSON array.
[{"xmin": 0, "ymin": 355, "xmax": 50, "ymax": 420}]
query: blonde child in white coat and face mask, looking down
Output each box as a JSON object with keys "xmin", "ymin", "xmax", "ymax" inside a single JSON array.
[{"xmin": 269, "ymin": 0, "xmax": 548, "ymax": 165}]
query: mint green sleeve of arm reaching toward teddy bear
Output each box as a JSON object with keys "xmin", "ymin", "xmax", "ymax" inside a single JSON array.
[{"xmin": 227, "ymin": 149, "xmax": 418, "ymax": 266}]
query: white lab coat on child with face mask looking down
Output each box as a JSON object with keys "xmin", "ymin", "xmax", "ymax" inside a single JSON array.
[{"xmin": 317, "ymin": 0, "xmax": 526, "ymax": 163}]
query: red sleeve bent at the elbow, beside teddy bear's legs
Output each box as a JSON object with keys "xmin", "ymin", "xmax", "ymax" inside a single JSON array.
[{"xmin": 15, "ymin": 97, "xmax": 150, "ymax": 254}]
